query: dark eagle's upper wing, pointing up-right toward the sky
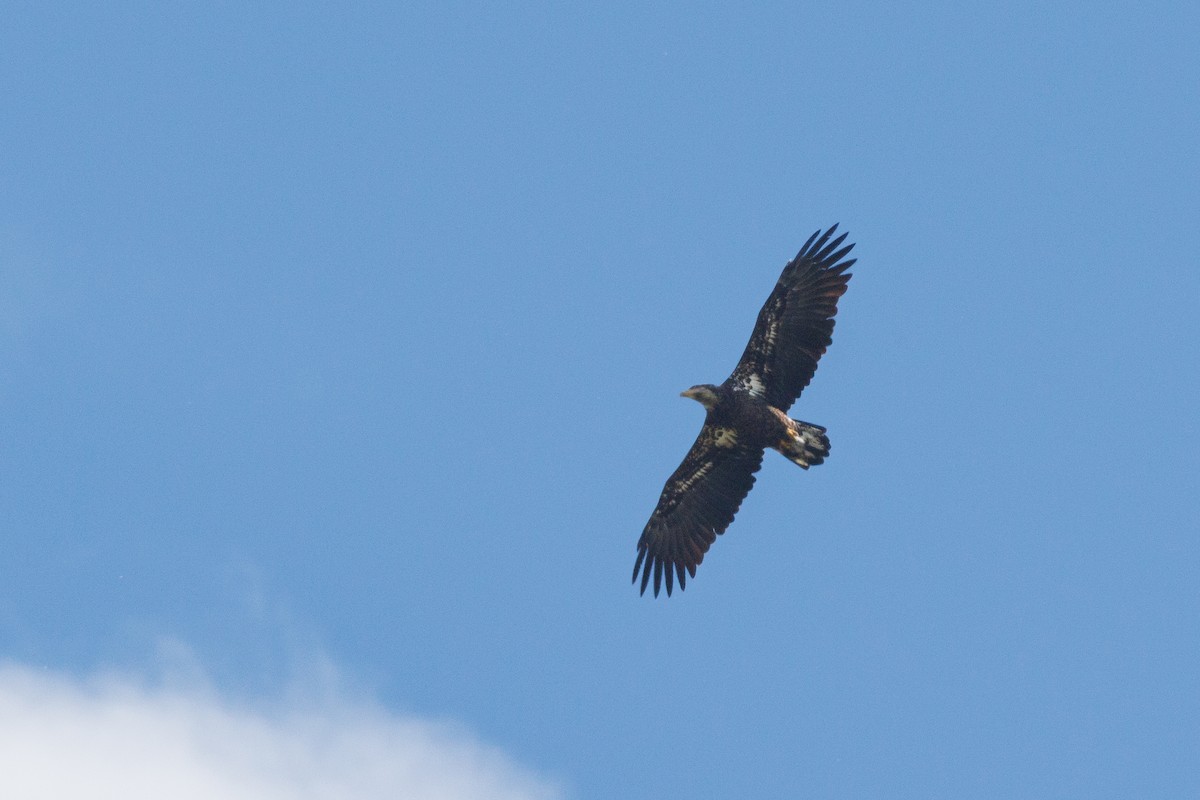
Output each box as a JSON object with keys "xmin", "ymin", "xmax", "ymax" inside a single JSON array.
[{"xmin": 728, "ymin": 225, "xmax": 854, "ymax": 411}]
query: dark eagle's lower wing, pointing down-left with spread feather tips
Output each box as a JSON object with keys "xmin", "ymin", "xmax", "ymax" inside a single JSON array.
[{"xmin": 634, "ymin": 425, "xmax": 763, "ymax": 597}]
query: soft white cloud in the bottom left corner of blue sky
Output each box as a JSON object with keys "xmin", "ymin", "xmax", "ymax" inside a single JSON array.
[{"xmin": 0, "ymin": 664, "xmax": 560, "ymax": 800}]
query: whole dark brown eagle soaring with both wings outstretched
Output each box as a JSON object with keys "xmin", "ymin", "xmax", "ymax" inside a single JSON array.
[{"xmin": 634, "ymin": 225, "xmax": 856, "ymax": 597}]
